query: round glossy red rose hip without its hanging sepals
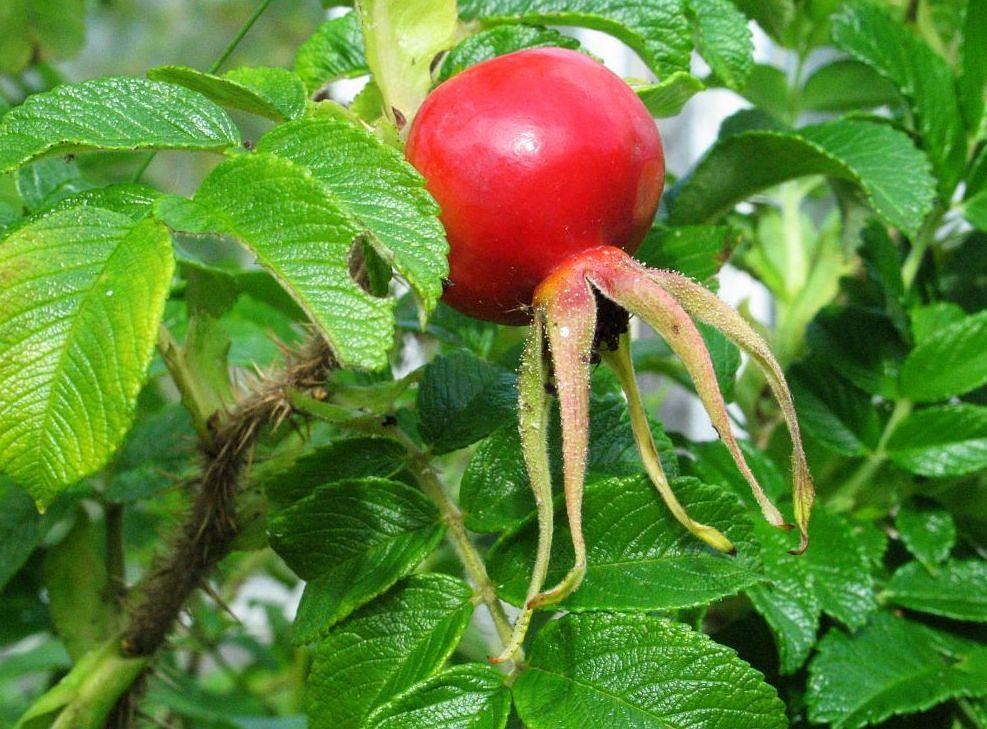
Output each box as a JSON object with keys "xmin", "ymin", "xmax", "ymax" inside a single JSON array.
[{"xmin": 406, "ymin": 48, "xmax": 665, "ymax": 324}]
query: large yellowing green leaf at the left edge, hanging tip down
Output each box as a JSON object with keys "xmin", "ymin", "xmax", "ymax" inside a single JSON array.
[{"xmin": 0, "ymin": 208, "xmax": 174, "ymax": 506}]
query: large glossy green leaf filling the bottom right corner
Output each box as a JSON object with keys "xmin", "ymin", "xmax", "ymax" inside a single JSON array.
[{"xmin": 806, "ymin": 613, "xmax": 987, "ymax": 729}]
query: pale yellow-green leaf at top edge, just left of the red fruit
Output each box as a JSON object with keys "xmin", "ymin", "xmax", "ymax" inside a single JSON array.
[{"xmin": 356, "ymin": 0, "xmax": 459, "ymax": 121}]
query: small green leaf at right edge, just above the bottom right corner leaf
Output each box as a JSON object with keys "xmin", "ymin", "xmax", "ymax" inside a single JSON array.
[{"xmin": 884, "ymin": 559, "xmax": 987, "ymax": 623}]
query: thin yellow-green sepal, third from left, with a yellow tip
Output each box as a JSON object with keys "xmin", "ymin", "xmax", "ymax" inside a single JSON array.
[{"xmin": 603, "ymin": 334, "xmax": 734, "ymax": 552}]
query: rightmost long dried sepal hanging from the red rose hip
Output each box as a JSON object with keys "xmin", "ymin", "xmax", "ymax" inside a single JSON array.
[{"xmin": 651, "ymin": 271, "xmax": 815, "ymax": 554}]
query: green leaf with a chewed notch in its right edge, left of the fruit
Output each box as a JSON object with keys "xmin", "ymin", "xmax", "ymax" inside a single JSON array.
[{"xmin": 155, "ymin": 154, "xmax": 394, "ymax": 369}]
